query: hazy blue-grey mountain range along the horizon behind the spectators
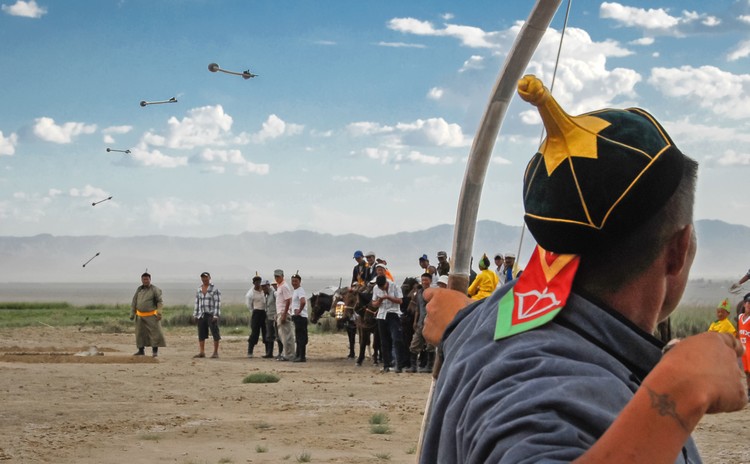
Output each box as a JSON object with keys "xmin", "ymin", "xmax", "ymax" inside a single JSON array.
[{"xmin": 0, "ymin": 220, "xmax": 750, "ymax": 282}]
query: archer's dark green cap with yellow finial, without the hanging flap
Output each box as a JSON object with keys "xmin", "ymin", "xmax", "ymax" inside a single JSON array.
[{"xmin": 518, "ymin": 76, "xmax": 685, "ymax": 254}]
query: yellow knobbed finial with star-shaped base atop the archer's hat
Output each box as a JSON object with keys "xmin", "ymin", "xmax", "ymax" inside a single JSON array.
[{"xmin": 518, "ymin": 75, "xmax": 609, "ymax": 176}]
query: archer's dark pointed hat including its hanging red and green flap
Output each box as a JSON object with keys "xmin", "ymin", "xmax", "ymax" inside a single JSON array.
[{"xmin": 495, "ymin": 76, "xmax": 686, "ymax": 340}]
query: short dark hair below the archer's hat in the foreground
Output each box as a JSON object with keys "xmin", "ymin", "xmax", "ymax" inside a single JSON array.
[{"xmin": 575, "ymin": 156, "xmax": 698, "ymax": 296}]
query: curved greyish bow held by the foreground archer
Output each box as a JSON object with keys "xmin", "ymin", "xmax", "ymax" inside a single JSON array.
[{"xmin": 417, "ymin": 0, "xmax": 562, "ymax": 462}]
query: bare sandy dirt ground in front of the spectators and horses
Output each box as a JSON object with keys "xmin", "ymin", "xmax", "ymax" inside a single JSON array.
[{"xmin": 0, "ymin": 327, "xmax": 750, "ymax": 464}]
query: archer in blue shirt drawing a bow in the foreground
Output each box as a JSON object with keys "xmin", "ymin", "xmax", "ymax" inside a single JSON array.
[{"xmin": 420, "ymin": 76, "xmax": 747, "ymax": 463}]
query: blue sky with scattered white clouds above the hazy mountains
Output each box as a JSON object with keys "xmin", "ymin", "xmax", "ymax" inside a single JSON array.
[{"xmin": 0, "ymin": 0, "xmax": 750, "ymax": 237}]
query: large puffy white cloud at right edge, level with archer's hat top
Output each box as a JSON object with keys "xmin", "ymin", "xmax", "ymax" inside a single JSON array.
[{"xmin": 648, "ymin": 66, "xmax": 750, "ymax": 119}]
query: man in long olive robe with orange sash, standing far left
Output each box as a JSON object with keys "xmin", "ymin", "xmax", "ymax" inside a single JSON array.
[{"xmin": 130, "ymin": 272, "xmax": 167, "ymax": 357}]
